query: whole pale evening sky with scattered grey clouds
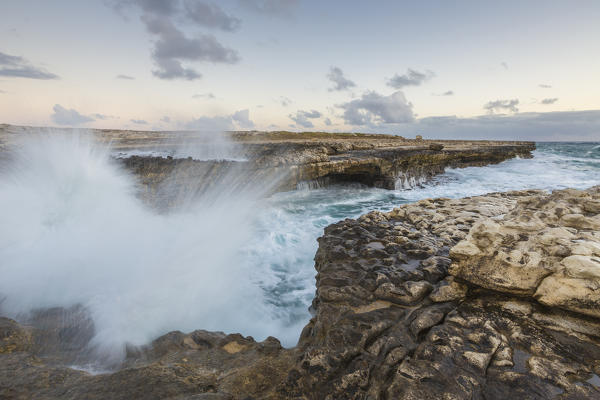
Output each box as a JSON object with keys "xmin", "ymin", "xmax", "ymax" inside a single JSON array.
[{"xmin": 0, "ymin": 0, "xmax": 600, "ymax": 141}]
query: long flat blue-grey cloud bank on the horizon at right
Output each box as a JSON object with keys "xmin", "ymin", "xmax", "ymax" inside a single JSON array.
[{"xmin": 384, "ymin": 110, "xmax": 600, "ymax": 141}]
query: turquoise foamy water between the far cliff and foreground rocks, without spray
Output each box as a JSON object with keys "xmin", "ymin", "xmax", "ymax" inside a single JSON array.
[{"xmin": 251, "ymin": 143, "xmax": 600, "ymax": 345}]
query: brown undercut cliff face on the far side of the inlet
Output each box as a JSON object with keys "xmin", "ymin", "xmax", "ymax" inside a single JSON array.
[{"xmin": 121, "ymin": 138, "xmax": 535, "ymax": 206}]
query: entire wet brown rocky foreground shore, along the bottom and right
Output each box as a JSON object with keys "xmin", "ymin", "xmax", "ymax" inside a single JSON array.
[{"xmin": 0, "ymin": 187, "xmax": 600, "ymax": 400}]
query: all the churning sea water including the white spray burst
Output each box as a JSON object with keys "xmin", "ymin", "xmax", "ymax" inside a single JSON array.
[{"xmin": 0, "ymin": 137, "xmax": 600, "ymax": 361}]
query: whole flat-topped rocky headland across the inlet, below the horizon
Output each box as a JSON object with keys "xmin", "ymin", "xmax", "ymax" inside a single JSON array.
[{"xmin": 0, "ymin": 125, "xmax": 535, "ymax": 200}]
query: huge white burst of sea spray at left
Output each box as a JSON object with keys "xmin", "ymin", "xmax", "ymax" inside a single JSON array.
[{"xmin": 0, "ymin": 133, "xmax": 284, "ymax": 362}]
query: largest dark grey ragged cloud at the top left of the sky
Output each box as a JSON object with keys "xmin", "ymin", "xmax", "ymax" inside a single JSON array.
[{"xmin": 111, "ymin": 0, "xmax": 241, "ymax": 81}]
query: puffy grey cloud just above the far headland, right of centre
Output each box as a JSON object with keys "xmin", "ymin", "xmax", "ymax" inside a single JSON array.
[{"xmin": 337, "ymin": 91, "xmax": 415, "ymax": 125}]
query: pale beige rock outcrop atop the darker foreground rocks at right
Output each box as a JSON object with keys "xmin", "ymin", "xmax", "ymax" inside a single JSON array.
[{"xmin": 449, "ymin": 187, "xmax": 600, "ymax": 317}]
